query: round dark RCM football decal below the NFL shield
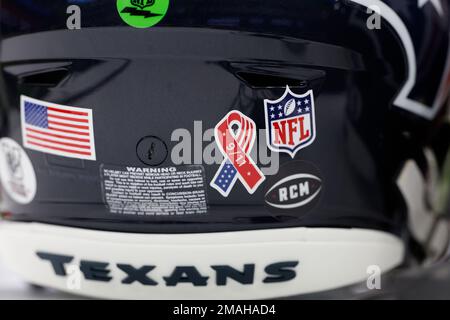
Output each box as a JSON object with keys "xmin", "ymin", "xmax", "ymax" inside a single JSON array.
[{"xmin": 264, "ymin": 161, "xmax": 323, "ymax": 217}]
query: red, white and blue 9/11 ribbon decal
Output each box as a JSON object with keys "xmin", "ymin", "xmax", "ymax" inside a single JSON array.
[{"xmin": 211, "ymin": 111, "xmax": 265, "ymax": 197}]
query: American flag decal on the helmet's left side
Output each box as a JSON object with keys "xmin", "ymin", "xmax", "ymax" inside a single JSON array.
[{"xmin": 20, "ymin": 96, "xmax": 96, "ymax": 160}]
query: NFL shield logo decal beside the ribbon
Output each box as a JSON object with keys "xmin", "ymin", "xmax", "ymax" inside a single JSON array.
[{"xmin": 264, "ymin": 87, "xmax": 316, "ymax": 158}]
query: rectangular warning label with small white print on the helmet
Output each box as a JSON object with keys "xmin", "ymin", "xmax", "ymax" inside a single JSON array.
[{"xmin": 100, "ymin": 165, "xmax": 207, "ymax": 216}]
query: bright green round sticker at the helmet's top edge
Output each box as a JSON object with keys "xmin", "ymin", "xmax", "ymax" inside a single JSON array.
[{"xmin": 117, "ymin": 0, "xmax": 169, "ymax": 28}]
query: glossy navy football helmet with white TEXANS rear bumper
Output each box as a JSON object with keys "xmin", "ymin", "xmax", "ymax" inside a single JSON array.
[{"xmin": 0, "ymin": 0, "xmax": 450, "ymax": 298}]
